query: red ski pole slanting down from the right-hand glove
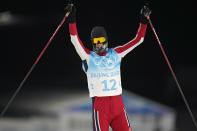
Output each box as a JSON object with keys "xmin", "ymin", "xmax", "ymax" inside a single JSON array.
[{"xmin": 147, "ymin": 16, "xmax": 197, "ymax": 128}]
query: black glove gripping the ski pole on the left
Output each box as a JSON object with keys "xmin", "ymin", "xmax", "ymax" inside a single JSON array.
[{"xmin": 65, "ymin": 3, "xmax": 76, "ymax": 23}]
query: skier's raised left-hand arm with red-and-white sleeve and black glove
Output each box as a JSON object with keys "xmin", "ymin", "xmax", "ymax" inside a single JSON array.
[{"xmin": 66, "ymin": 4, "xmax": 90, "ymax": 60}]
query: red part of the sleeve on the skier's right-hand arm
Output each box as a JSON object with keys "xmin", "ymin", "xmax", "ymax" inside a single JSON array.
[{"xmin": 114, "ymin": 24, "xmax": 147, "ymax": 54}]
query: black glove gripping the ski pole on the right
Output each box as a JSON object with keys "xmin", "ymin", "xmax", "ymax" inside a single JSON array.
[{"xmin": 140, "ymin": 4, "xmax": 151, "ymax": 24}]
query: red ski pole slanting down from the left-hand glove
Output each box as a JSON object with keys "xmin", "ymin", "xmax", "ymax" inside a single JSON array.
[{"xmin": 0, "ymin": 10, "xmax": 73, "ymax": 117}]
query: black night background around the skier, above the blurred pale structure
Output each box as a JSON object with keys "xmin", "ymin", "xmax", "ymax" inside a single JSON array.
[{"xmin": 0, "ymin": 0, "xmax": 197, "ymax": 131}]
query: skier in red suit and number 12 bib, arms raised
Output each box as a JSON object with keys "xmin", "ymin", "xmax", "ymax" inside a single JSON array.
[{"xmin": 66, "ymin": 4, "xmax": 151, "ymax": 131}]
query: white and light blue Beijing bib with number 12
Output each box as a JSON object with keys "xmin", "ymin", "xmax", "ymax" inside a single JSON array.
[{"xmin": 83, "ymin": 49, "xmax": 122, "ymax": 97}]
